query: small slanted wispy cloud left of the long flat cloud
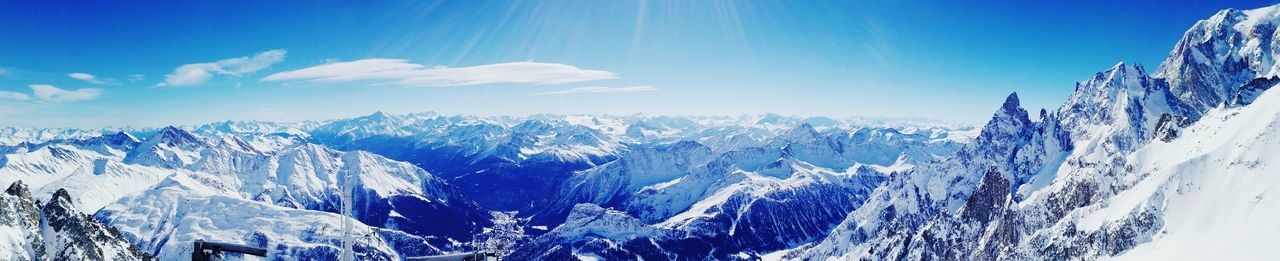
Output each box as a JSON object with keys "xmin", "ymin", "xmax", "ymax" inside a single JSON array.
[{"xmin": 156, "ymin": 50, "xmax": 285, "ymax": 87}]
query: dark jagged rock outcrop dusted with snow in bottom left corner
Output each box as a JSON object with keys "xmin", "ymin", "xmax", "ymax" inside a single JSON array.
[{"xmin": 0, "ymin": 182, "xmax": 151, "ymax": 260}]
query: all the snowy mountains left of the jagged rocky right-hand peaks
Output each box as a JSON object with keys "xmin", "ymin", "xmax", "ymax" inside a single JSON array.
[{"xmin": 0, "ymin": 113, "xmax": 972, "ymax": 260}]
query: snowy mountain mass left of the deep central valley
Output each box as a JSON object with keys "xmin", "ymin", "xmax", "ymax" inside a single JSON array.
[{"xmin": 0, "ymin": 127, "xmax": 490, "ymax": 260}]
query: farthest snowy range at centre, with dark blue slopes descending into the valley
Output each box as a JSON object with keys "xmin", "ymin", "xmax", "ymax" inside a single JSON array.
[{"xmin": 302, "ymin": 113, "xmax": 964, "ymax": 210}]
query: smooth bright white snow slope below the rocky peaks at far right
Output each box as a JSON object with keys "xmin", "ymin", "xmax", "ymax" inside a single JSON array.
[{"xmin": 1020, "ymin": 82, "xmax": 1280, "ymax": 260}]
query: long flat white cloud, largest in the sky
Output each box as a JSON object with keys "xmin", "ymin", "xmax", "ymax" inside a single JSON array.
[{"xmin": 262, "ymin": 59, "xmax": 618, "ymax": 86}]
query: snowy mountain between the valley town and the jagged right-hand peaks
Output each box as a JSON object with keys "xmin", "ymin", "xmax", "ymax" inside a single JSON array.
[{"xmin": 506, "ymin": 123, "xmax": 961, "ymax": 258}]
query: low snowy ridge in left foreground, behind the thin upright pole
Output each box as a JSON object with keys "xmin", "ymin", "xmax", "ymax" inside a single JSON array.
[{"xmin": 95, "ymin": 174, "xmax": 424, "ymax": 260}]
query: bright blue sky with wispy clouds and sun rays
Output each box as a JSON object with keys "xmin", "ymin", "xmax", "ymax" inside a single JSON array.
[{"xmin": 0, "ymin": 1, "xmax": 1271, "ymax": 128}]
